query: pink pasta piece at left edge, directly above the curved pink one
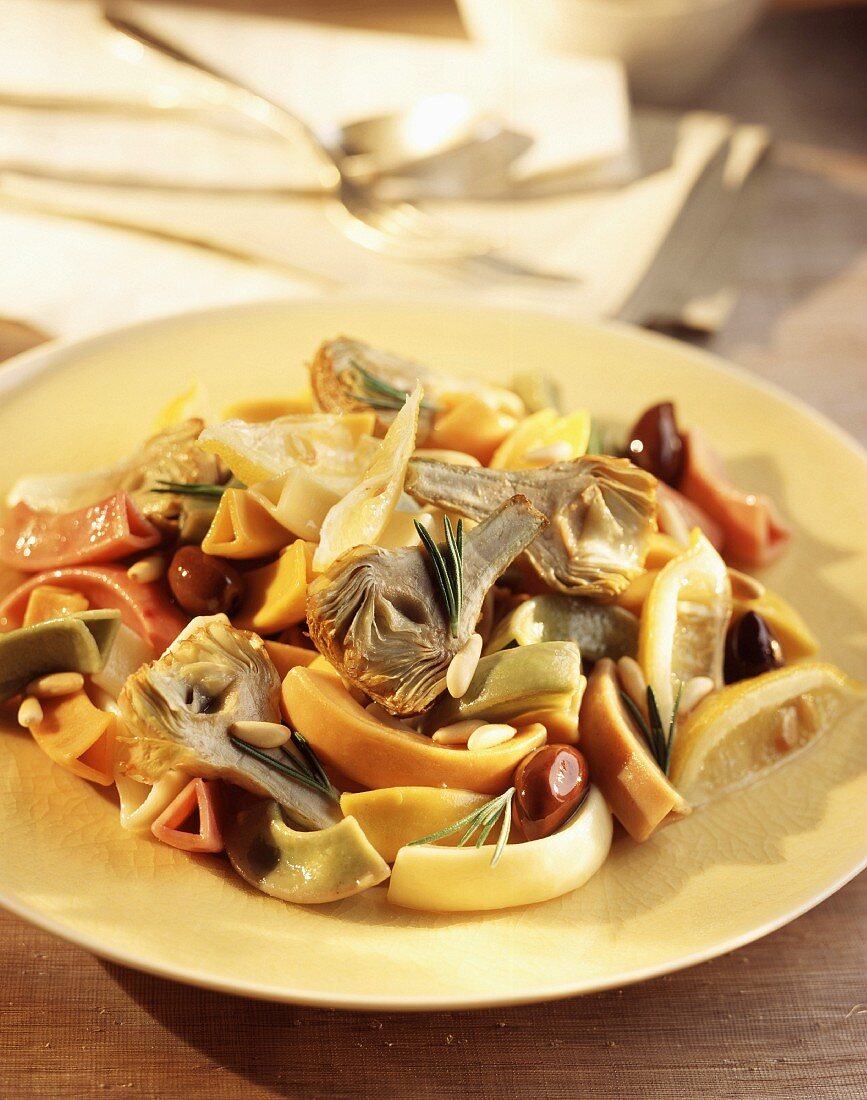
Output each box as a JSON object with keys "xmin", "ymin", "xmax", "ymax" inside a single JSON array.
[{"xmin": 0, "ymin": 493, "xmax": 161, "ymax": 573}]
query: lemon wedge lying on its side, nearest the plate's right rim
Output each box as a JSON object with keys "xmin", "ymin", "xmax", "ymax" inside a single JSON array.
[{"xmin": 669, "ymin": 661, "xmax": 867, "ymax": 804}]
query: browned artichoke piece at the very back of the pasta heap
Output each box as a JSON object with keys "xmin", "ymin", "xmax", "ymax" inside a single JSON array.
[{"xmin": 310, "ymin": 337, "xmax": 524, "ymax": 437}]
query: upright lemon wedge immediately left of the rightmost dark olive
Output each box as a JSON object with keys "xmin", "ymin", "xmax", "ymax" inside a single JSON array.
[{"xmin": 638, "ymin": 527, "xmax": 732, "ymax": 729}]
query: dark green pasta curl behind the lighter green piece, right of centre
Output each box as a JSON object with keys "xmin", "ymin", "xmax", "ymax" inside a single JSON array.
[{"xmin": 485, "ymin": 592, "xmax": 638, "ymax": 661}]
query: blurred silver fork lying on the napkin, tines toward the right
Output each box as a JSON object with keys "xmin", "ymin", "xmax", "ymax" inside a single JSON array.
[{"xmin": 103, "ymin": 3, "xmax": 495, "ymax": 261}]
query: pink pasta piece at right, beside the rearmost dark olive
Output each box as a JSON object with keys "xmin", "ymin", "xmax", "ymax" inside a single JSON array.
[{"xmin": 680, "ymin": 430, "xmax": 791, "ymax": 565}]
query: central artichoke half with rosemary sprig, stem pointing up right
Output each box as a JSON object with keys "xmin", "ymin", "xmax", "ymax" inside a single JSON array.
[{"xmin": 307, "ymin": 496, "xmax": 546, "ymax": 715}]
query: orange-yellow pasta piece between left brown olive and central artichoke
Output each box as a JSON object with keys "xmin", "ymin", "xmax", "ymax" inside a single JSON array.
[{"xmin": 232, "ymin": 539, "xmax": 314, "ymax": 634}]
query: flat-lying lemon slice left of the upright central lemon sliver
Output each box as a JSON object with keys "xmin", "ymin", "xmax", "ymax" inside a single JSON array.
[{"xmin": 199, "ymin": 413, "xmax": 376, "ymax": 485}]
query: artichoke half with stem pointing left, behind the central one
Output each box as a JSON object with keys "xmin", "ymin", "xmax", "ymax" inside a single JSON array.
[{"xmin": 405, "ymin": 455, "xmax": 656, "ymax": 597}]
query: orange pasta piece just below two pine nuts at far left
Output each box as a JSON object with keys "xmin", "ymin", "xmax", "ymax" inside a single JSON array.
[{"xmin": 30, "ymin": 691, "xmax": 117, "ymax": 787}]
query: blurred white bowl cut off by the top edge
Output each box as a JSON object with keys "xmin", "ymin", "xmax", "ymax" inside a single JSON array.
[{"xmin": 458, "ymin": 0, "xmax": 765, "ymax": 103}]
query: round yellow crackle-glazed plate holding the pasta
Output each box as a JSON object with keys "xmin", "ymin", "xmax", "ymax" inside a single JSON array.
[{"xmin": 0, "ymin": 299, "xmax": 867, "ymax": 1009}]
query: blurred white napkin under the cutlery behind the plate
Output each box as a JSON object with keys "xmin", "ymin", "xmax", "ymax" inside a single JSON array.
[{"xmin": 0, "ymin": 0, "xmax": 765, "ymax": 343}]
